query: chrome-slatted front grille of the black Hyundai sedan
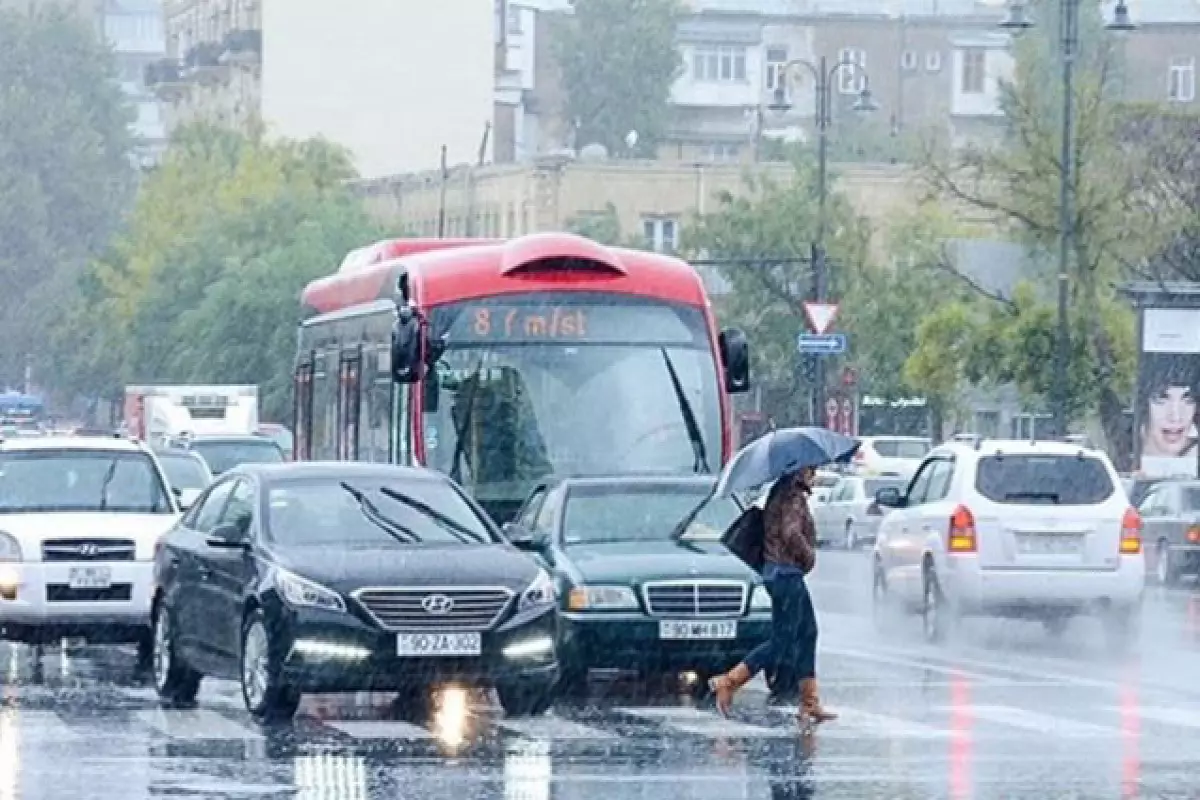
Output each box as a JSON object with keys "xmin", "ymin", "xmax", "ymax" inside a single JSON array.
[{"xmin": 353, "ymin": 587, "xmax": 512, "ymax": 631}]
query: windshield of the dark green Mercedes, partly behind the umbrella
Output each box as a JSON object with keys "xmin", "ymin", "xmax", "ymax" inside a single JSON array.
[{"xmin": 563, "ymin": 486, "xmax": 739, "ymax": 546}]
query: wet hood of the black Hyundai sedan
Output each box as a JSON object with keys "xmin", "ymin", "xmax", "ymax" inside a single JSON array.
[{"xmin": 270, "ymin": 545, "xmax": 540, "ymax": 594}]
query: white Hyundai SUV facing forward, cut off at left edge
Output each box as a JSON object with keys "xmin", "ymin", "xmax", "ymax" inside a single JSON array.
[{"xmin": 0, "ymin": 437, "xmax": 179, "ymax": 660}]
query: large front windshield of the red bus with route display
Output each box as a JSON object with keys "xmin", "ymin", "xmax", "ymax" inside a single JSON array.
[{"xmin": 424, "ymin": 293, "xmax": 721, "ymax": 518}]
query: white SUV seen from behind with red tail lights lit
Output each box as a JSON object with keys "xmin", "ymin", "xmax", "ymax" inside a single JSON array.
[{"xmin": 874, "ymin": 440, "xmax": 1146, "ymax": 646}]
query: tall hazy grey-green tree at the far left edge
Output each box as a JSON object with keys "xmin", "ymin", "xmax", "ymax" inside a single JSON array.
[{"xmin": 0, "ymin": 8, "xmax": 134, "ymax": 381}]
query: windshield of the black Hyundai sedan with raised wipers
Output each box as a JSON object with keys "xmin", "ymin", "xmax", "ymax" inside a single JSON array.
[{"xmin": 266, "ymin": 479, "xmax": 497, "ymax": 548}]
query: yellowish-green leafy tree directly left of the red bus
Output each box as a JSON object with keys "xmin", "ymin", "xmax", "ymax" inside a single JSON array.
[{"xmin": 56, "ymin": 128, "xmax": 380, "ymax": 419}]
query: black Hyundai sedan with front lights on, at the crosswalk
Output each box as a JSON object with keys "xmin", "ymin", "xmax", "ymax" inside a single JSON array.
[{"xmin": 151, "ymin": 462, "xmax": 557, "ymax": 720}]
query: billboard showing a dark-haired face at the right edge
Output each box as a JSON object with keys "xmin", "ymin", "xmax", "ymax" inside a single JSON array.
[{"xmin": 1134, "ymin": 308, "xmax": 1200, "ymax": 477}]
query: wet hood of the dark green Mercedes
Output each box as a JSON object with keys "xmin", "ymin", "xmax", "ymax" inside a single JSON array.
[{"xmin": 565, "ymin": 541, "xmax": 756, "ymax": 584}]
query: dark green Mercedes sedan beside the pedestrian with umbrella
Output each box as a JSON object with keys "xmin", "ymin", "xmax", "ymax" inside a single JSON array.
[{"xmin": 504, "ymin": 475, "xmax": 770, "ymax": 691}]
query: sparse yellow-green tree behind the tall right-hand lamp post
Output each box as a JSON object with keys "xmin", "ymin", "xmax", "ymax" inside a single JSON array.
[{"xmin": 925, "ymin": 0, "xmax": 1147, "ymax": 455}]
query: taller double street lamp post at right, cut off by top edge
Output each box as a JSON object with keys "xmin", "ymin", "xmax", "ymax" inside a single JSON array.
[{"xmin": 1000, "ymin": 0, "xmax": 1134, "ymax": 438}]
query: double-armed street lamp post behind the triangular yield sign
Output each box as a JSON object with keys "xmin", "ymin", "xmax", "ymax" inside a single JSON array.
[{"xmin": 768, "ymin": 56, "xmax": 878, "ymax": 425}]
